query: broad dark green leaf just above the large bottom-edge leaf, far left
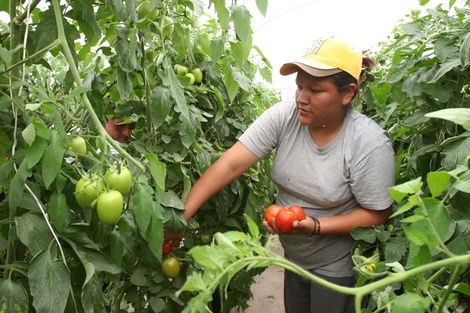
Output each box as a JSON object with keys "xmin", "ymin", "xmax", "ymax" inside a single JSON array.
[{"xmin": 15, "ymin": 213, "xmax": 53, "ymax": 256}]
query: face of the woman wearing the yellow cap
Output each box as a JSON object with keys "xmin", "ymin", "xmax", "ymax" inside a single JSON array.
[{"xmin": 295, "ymin": 71, "xmax": 356, "ymax": 129}]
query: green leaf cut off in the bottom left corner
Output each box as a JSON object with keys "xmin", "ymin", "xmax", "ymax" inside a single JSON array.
[{"xmin": 0, "ymin": 279, "xmax": 29, "ymax": 313}]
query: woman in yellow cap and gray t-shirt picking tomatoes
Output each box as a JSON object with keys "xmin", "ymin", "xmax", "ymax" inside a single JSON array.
[{"xmin": 167, "ymin": 37, "xmax": 395, "ymax": 313}]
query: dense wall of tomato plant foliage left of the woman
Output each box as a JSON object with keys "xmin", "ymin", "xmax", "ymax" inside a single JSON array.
[{"xmin": 0, "ymin": 0, "xmax": 279, "ymax": 313}]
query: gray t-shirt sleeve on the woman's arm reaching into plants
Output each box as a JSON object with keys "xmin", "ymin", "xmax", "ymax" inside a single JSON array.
[{"xmin": 238, "ymin": 102, "xmax": 289, "ymax": 159}]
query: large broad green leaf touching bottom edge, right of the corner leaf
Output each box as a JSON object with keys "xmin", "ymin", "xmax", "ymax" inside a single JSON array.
[{"xmin": 28, "ymin": 251, "xmax": 71, "ymax": 313}]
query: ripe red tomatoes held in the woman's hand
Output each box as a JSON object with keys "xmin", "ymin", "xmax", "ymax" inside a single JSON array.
[{"xmin": 264, "ymin": 204, "xmax": 307, "ymax": 233}]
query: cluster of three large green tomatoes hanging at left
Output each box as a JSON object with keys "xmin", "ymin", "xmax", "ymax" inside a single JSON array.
[{"xmin": 75, "ymin": 165, "xmax": 132, "ymax": 225}]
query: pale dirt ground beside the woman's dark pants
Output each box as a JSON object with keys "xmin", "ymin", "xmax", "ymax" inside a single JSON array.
[{"xmin": 230, "ymin": 236, "xmax": 284, "ymax": 313}]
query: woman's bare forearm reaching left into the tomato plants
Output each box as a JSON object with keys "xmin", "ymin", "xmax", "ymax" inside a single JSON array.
[{"xmin": 184, "ymin": 142, "xmax": 259, "ymax": 221}]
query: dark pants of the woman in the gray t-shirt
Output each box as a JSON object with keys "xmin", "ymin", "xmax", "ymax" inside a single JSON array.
[{"xmin": 284, "ymin": 270, "xmax": 356, "ymax": 313}]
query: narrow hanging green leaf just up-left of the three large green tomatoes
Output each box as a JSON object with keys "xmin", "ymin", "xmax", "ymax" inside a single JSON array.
[{"xmin": 41, "ymin": 130, "xmax": 67, "ymax": 188}]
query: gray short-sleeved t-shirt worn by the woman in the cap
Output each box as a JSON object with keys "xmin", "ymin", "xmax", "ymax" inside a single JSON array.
[{"xmin": 239, "ymin": 101, "xmax": 395, "ymax": 277}]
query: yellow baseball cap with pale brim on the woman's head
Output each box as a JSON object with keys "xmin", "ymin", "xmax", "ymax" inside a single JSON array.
[{"xmin": 280, "ymin": 37, "xmax": 362, "ymax": 81}]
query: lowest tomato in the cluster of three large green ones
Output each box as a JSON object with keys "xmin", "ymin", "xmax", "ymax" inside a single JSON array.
[{"xmin": 96, "ymin": 190, "xmax": 124, "ymax": 225}]
